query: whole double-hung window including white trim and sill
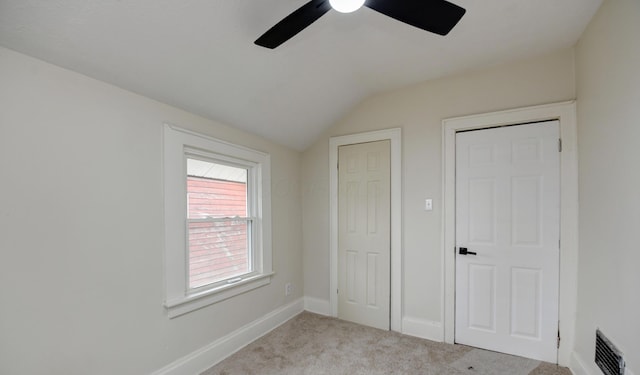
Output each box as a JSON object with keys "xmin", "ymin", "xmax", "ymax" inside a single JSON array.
[{"xmin": 164, "ymin": 125, "xmax": 272, "ymax": 317}]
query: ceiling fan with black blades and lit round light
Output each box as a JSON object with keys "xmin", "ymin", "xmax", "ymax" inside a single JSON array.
[{"xmin": 254, "ymin": 0, "xmax": 466, "ymax": 49}]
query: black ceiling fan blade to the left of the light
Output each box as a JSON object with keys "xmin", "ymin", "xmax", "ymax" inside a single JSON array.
[{"xmin": 254, "ymin": 0, "xmax": 331, "ymax": 49}]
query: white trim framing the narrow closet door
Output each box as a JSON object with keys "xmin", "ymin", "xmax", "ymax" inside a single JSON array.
[{"xmin": 329, "ymin": 128, "xmax": 402, "ymax": 332}]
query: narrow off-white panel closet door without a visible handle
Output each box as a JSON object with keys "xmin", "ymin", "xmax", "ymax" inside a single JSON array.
[{"xmin": 338, "ymin": 141, "xmax": 391, "ymax": 330}]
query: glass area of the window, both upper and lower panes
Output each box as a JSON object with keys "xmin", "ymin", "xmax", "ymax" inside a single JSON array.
[{"xmin": 187, "ymin": 155, "xmax": 254, "ymax": 290}]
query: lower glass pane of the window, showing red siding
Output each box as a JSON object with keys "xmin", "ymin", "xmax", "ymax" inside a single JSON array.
[{"xmin": 189, "ymin": 220, "xmax": 252, "ymax": 289}]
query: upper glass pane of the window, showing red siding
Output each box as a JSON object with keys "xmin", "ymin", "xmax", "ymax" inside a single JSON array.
[{"xmin": 187, "ymin": 159, "xmax": 248, "ymax": 219}]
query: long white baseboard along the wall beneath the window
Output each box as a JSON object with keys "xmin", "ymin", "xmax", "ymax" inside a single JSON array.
[{"xmin": 152, "ymin": 298, "xmax": 304, "ymax": 375}]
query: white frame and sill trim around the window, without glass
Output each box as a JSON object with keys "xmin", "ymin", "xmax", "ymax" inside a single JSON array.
[{"xmin": 163, "ymin": 124, "xmax": 273, "ymax": 318}]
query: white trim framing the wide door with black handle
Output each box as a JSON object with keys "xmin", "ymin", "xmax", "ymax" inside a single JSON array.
[{"xmin": 441, "ymin": 101, "xmax": 578, "ymax": 366}]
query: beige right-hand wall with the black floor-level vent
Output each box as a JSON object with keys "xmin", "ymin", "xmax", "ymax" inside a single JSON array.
[{"xmin": 576, "ymin": 0, "xmax": 640, "ymax": 374}]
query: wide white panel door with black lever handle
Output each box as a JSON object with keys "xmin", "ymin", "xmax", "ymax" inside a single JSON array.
[{"xmin": 455, "ymin": 121, "xmax": 560, "ymax": 363}]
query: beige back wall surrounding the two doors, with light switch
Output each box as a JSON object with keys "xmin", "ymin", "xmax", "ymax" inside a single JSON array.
[{"xmin": 302, "ymin": 49, "xmax": 575, "ymax": 322}]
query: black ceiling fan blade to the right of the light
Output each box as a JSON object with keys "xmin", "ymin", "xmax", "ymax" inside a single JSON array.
[{"xmin": 364, "ymin": 0, "xmax": 466, "ymax": 35}]
